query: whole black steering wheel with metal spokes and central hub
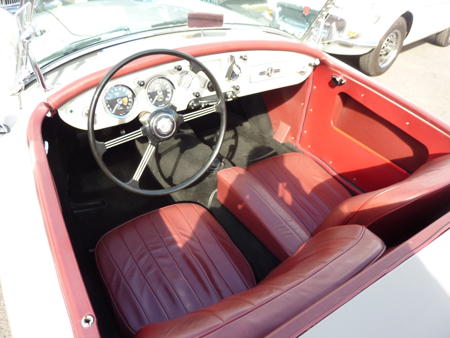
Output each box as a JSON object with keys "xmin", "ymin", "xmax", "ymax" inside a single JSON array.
[{"xmin": 87, "ymin": 49, "xmax": 227, "ymax": 196}]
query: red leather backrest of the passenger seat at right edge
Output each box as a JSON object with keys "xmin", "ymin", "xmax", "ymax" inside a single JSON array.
[{"xmin": 317, "ymin": 155, "xmax": 450, "ymax": 233}]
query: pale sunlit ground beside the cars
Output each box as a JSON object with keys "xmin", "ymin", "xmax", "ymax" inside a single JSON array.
[{"xmin": 0, "ymin": 35, "xmax": 450, "ymax": 338}]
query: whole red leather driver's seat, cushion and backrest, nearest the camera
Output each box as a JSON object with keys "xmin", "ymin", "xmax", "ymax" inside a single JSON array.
[{"xmin": 96, "ymin": 204, "xmax": 384, "ymax": 337}]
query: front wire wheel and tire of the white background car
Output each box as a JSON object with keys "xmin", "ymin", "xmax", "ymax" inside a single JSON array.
[{"xmin": 359, "ymin": 17, "xmax": 407, "ymax": 76}]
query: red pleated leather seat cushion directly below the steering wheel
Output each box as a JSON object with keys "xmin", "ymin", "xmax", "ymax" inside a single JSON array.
[{"xmin": 96, "ymin": 204, "xmax": 255, "ymax": 334}]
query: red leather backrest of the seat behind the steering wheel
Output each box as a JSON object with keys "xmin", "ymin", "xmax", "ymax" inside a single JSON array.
[{"xmin": 137, "ymin": 225, "xmax": 384, "ymax": 338}]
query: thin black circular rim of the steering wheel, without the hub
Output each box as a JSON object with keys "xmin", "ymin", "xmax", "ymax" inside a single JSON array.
[{"xmin": 87, "ymin": 49, "xmax": 227, "ymax": 196}]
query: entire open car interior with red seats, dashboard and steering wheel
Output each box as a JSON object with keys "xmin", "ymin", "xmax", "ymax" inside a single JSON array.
[{"xmin": 36, "ymin": 43, "xmax": 450, "ymax": 337}]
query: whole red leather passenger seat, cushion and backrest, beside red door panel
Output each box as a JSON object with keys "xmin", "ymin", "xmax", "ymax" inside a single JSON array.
[{"xmin": 217, "ymin": 153, "xmax": 450, "ymax": 260}]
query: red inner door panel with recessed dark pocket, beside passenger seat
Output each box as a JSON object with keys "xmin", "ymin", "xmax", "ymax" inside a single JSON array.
[{"xmin": 296, "ymin": 65, "xmax": 450, "ymax": 191}]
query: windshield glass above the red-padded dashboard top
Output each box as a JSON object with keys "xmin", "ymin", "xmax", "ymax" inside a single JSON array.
[{"xmin": 30, "ymin": 0, "xmax": 325, "ymax": 66}]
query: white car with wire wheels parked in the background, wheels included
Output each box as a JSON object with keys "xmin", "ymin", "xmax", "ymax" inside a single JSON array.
[{"xmin": 268, "ymin": 0, "xmax": 450, "ymax": 76}]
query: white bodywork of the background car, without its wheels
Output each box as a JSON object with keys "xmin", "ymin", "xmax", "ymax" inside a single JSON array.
[{"xmin": 269, "ymin": 0, "xmax": 450, "ymax": 55}]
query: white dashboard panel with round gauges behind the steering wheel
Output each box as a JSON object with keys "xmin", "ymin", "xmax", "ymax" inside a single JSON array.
[{"xmin": 59, "ymin": 50, "xmax": 318, "ymax": 130}]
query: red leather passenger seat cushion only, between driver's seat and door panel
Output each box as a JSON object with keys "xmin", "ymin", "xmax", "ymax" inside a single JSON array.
[{"xmin": 217, "ymin": 153, "xmax": 351, "ymax": 260}]
